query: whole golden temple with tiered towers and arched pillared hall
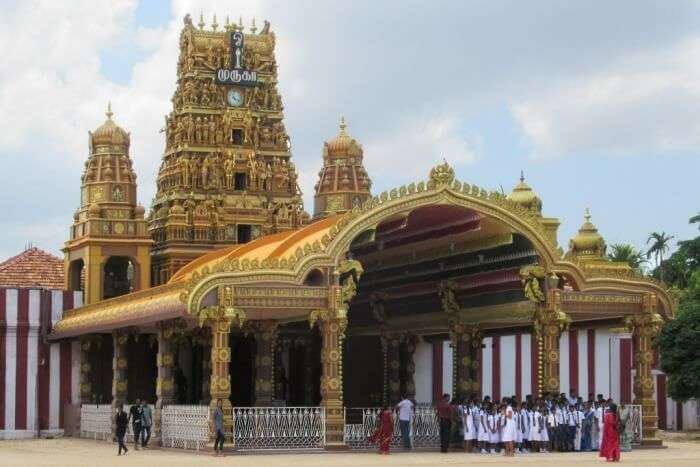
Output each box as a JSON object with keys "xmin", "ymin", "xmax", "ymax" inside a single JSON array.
[{"xmin": 39, "ymin": 16, "xmax": 675, "ymax": 448}]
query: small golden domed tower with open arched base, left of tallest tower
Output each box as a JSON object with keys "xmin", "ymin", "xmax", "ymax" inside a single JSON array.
[{"xmin": 63, "ymin": 105, "xmax": 153, "ymax": 304}]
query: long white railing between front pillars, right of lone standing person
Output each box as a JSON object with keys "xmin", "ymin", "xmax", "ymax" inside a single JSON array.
[{"xmin": 233, "ymin": 407, "xmax": 326, "ymax": 450}]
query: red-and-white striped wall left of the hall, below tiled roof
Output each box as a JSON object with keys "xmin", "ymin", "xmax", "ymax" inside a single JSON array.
[{"xmin": 0, "ymin": 288, "xmax": 82, "ymax": 439}]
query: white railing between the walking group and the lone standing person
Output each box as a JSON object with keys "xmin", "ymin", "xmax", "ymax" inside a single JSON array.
[{"xmin": 160, "ymin": 405, "xmax": 209, "ymax": 450}]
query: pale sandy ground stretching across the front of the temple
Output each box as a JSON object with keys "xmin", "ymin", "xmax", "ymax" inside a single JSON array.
[{"xmin": 0, "ymin": 438, "xmax": 700, "ymax": 467}]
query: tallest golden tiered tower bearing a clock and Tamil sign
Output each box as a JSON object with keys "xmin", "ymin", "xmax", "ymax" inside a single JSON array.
[{"xmin": 148, "ymin": 15, "xmax": 309, "ymax": 285}]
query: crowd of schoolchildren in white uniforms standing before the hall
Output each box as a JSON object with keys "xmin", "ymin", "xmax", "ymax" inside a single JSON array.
[{"xmin": 455, "ymin": 394, "xmax": 612, "ymax": 455}]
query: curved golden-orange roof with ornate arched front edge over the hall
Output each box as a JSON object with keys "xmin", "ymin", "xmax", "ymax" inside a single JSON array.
[{"xmin": 51, "ymin": 163, "xmax": 675, "ymax": 339}]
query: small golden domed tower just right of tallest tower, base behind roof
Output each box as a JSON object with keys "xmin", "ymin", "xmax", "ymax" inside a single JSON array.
[{"xmin": 313, "ymin": 118, "xmax": 372, "ymax": 220}]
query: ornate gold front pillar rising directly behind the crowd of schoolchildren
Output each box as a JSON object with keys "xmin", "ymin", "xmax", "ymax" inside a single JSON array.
[{"xmin": 534, "ymin": 290, "xmax": 571, "ymax": 394}]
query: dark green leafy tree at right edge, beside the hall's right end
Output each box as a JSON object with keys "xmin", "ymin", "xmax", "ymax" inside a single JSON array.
[{"xmin": 654, "ymin": 270, "xmax": 700, "ymax": 401}]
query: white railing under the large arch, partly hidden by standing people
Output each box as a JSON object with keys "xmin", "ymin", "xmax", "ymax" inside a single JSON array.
[{"xmin": 345, "ymin": 407, "xmax": 440, "ymax": 449}]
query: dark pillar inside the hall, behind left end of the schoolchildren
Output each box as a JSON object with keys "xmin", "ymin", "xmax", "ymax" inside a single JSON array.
[{"xmin": 450, "ymin": 320, "xmax": 481, "ymax": 401}]
